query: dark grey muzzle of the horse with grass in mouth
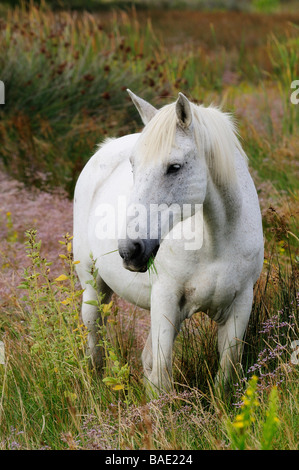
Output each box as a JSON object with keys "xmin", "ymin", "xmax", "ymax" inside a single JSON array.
[{"xmin": 118, "ymin": 238, "xmax": 160, "ymax": 273}]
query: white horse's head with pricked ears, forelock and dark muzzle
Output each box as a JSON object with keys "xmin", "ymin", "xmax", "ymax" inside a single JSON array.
[{"xmin": 118, "ymin": 91, "xmax": 207, "ymax": 272}]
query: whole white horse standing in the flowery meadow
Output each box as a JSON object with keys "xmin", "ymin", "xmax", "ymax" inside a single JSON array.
[{"xmin": 74, "ymin": 90, "xmax": 264, "ymax": 391}]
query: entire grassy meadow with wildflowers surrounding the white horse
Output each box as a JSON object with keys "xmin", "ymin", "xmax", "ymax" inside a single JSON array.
[{"xmin": 0, "ymin": 0, "xmax": 299, "ymax": 450}]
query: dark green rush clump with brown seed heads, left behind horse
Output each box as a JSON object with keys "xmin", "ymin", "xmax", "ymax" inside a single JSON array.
[{"xmin": 0, "ymin": 6, "xmax": 162, "ymax": 193}]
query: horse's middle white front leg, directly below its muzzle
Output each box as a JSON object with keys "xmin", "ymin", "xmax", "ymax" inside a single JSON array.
[{"xmin": 142, "ymin": 288, "xmax": 181, "ymax": 394}]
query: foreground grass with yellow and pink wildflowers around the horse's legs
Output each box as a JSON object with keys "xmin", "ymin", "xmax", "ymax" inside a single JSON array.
[{"xmin": 0, "ymin": 226, "xmax": 298, "ymax": 449}]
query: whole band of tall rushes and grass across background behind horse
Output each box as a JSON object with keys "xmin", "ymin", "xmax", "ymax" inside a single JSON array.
[{"xmin": 0, "ymin": 3, "xmax": 298, "ymax": 196}]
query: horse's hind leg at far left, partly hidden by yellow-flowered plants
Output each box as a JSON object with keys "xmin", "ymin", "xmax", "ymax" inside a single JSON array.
[{"xmin": 82, "ymin": 278, "xmax": 113, "ymax": 371}]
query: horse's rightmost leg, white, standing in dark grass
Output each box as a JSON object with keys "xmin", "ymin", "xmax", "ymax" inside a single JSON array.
[{"xmin": 215, "ymin": 287, "xmax": 253, "ymax": 391}]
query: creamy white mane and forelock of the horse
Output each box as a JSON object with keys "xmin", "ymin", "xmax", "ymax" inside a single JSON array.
[{"xmin": 136, "ymin": 103, "xmax": 247, "ymax": 184}]
